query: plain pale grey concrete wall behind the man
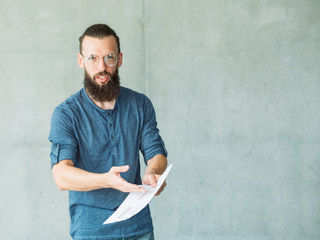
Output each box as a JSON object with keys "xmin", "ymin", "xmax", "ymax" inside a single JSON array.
[{"xmin": 0, "ymin": 0, "xmax": 320, "ymax": 240}]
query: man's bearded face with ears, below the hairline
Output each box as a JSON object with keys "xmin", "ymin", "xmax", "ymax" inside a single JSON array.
[{"xmin": 78, "ymin": 36, "xmax": 122, "ymax": 101}]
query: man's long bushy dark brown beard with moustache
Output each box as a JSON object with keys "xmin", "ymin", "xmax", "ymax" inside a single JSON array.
[{"xmin": 83, "ymin": 68, "xmax": 120, "ymax": 102}]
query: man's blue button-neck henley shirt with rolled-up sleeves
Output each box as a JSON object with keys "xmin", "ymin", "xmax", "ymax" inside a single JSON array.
[{"xmin": 49, "ymin": 87, "xmax": 167, "ymax": 239}]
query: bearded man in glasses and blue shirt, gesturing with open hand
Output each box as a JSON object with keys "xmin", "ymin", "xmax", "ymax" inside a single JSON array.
[{"xmin": 49, "ymin": 24, "xmax": 167, "ymax": 240}]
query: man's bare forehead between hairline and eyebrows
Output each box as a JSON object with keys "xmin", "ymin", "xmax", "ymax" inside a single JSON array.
[{"xmin": 82, "ymin": 36, "xmax": 118, "ymax": 56}]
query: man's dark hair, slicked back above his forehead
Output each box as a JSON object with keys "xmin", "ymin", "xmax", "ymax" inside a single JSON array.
[{"xmin": 79, "ymin": 24, "xmax": 120, "ymax": 54}]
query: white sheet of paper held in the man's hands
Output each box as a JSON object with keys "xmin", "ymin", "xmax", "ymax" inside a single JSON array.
[{"xmin": 103, "ymin": 164, "xmax": 172, "ymax": 224}]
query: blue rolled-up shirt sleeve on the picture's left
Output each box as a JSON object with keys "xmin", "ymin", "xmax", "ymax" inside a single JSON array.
[{"xmin": 49, "ymin": 107, "xmax": 78, "ymax": 168}]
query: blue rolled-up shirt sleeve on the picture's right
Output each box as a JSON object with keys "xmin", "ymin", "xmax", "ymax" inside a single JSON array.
[{"xmin": 140, "ymin": 97, "xmax": 168, "ymax": 162}]
